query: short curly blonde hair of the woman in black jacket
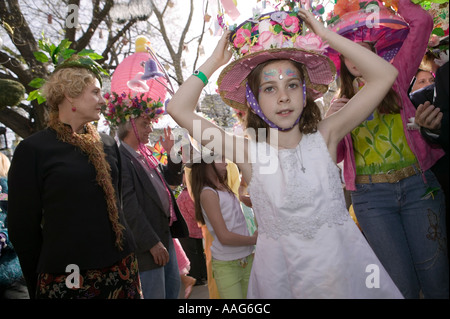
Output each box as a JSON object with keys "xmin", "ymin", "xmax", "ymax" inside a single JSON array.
[{"xmin": 42, "ymin": 67, "xmax": 96, "ymax": 113}]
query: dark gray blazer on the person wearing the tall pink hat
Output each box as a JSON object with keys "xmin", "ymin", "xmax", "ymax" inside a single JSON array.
[{"xmin": 119, "ymin": 144, "xmax": 189, "ymax": 271}]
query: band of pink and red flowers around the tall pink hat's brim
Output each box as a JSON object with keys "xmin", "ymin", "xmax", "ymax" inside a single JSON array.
[{"xmin": 102, "ymin": 92, "xmax": 164, "ymax": 127}]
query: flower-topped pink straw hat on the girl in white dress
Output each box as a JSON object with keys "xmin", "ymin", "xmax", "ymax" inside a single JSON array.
[{"xmin": 218, "ymin": 11, "xmax": 336, "ymax": 110}]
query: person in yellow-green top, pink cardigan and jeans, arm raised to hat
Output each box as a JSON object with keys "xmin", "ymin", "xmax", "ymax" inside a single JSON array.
[{"xmin": 328, "ymin": 0, "xmax": 449, "ymax": 298}]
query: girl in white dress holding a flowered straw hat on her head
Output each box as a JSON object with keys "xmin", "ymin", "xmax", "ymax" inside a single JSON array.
[{"xmin": 167, "ymin": 8, "xmax": 402, "ymax": 298}]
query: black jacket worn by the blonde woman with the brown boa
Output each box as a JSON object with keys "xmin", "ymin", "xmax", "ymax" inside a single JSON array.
[{"xmin": 8, "ymin": 129, "xmax": 133, "ymax": 297}]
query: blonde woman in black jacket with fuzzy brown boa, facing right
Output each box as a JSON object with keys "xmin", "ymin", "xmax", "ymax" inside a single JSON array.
[{"xmin": 8, "ymin": 57, "xmax": 141, "ymax": 299}]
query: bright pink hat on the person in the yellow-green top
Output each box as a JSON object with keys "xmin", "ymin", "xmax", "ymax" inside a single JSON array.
[{"xmin": 327, "ymin": 0, "xmax": 409, "ymax": 70}]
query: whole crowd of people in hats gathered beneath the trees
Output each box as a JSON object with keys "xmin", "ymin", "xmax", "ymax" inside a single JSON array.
[{"xmin": 0, "ymin": 0, "xmax": 449, "ymax": 299}]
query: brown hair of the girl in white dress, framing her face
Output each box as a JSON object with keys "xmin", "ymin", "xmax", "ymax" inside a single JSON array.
[{"xmin": 245, "ymin": 60, "xmax": 322, "ymax": 140}]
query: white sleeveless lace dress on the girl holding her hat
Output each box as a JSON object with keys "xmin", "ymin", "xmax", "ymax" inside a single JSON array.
[{"xmin": 247, "ymin": 132, "xmax": 402, "ymax": 299}]
